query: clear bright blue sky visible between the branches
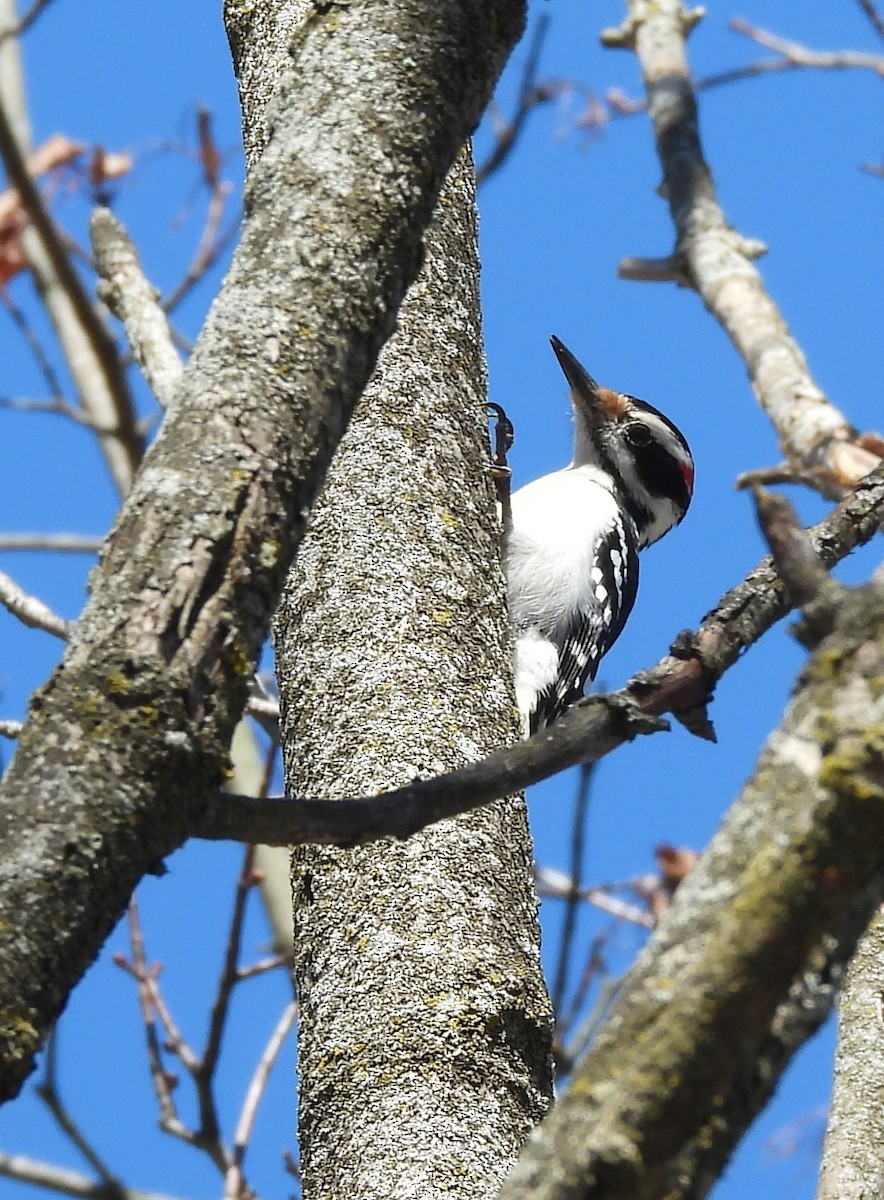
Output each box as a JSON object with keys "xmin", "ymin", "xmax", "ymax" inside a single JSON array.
[{"xmin": 0, "ymin": 0, "xmax": 884, "ymax": 1200}]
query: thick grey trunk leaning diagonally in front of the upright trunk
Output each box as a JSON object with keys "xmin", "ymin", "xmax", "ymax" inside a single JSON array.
[{"xmin": 0, "ymin": 0, "xmax": 524, "ymax": 1099}]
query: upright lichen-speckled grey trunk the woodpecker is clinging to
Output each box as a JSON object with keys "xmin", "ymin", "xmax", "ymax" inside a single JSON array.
[{"xmin": 275, "ymin": 147, "xmax": 552, "ymax": 1200}]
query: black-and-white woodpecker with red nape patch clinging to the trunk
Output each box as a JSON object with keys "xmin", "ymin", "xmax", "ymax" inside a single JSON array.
[{"xmin": 504, "ymin": 337, "xmax": 693, "ymax": 733}]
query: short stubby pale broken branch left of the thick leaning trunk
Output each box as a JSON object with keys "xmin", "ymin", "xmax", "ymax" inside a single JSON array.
[{"xmin": 90, "ymin": 208, "xmax": 182, "ymax": 408}]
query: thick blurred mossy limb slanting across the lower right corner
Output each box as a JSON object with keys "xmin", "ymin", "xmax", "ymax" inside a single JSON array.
[{"xmin": 500, "ymin": 568, "xmax": 884, "ymax": 1200}]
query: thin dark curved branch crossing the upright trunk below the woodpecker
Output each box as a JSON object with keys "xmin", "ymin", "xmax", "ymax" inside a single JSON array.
[{"xmin": 191, "ymin": 464, "xmax": 884, "ymax": 846}]
